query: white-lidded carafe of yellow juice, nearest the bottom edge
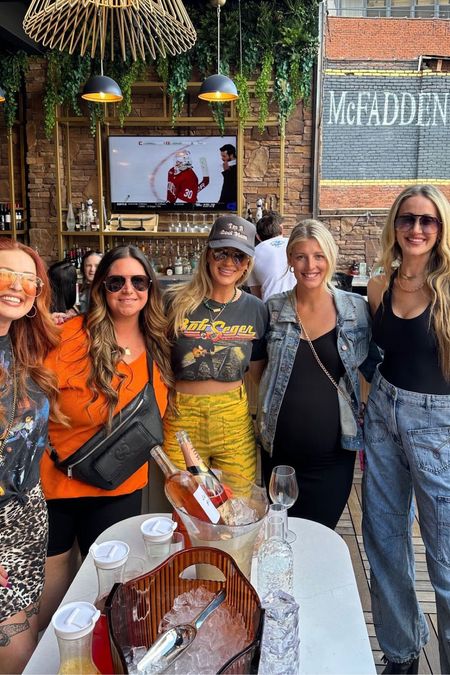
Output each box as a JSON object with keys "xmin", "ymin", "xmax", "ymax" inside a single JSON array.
[{"xmin": 52, "ymin": 602, "xmax": 100, "ymax": 675}]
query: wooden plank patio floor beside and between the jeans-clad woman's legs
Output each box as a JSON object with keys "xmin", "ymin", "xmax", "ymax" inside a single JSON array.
[{"xmin": 336, "ymin": 470, "xmax": 440, "ymax": 673}]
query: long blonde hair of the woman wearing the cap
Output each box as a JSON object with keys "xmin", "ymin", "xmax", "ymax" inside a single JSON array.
[{"xmin": 166, "ymin": 245, "xmax": 253, "ymax": 338}]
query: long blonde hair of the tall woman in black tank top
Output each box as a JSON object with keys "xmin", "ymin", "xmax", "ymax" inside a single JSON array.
[{"xmin": 380, "ymin": 185, "xmax": 450, "ymax": 381}]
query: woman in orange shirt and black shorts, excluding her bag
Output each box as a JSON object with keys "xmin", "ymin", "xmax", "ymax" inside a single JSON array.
[{"xmin": 41, "ymin": 246, "xmax": 171, "ymax": 626}]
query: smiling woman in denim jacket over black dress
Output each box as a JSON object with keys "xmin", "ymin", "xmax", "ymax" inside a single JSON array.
[{"xmin": 258, "ymin": 220, "xmax": 379, "ymax": 528}]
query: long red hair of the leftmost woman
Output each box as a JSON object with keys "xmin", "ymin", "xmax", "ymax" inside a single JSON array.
[{"xmin": 0, "ymin": 238, "xmax": 67, "ymax": 424}]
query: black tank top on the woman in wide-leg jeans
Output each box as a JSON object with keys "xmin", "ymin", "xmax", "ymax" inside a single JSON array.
[{"xmin": 372, "ymin": 277, "xmax": 450, "ymax": 395}]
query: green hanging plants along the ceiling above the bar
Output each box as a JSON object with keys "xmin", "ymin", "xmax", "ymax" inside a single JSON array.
[{"xmin": 27, "ymin": 0, "xmax": 318, "ymax": 135}]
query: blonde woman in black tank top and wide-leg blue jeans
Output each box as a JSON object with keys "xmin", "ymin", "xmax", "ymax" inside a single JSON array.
[{"xmin": 363, "ymin": 185, "xmax": 450, "ymax": 673}]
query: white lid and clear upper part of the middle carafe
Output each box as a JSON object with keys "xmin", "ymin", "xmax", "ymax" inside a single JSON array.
[{"xmin": 89, "ymin": 539, "xmax": 130, "ymax": 609}]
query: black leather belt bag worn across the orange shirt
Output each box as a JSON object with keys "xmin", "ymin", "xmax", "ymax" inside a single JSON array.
[{"xmin": 48, "ymin": 374, "xmax": 163, "ymax": 490}]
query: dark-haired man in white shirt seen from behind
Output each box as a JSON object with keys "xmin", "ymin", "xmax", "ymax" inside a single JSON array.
[{"xmin": 247, "ymin": 211, "xmax": 296, "ymax": 302}]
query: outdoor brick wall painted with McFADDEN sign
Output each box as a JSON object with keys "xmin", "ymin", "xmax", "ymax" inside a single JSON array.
[{"xmin": 319, "ymin": 17, "xmax": 450, "ymax": 266}]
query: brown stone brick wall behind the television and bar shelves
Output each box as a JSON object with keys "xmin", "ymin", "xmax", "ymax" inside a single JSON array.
[{"xmin": 4, "ymin": 59, "xmax": 312, "ymax": 261}]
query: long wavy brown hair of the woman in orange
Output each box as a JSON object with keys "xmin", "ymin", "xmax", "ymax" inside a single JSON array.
[{"xmin": 84, "ymin": 246, "xmax": 173, "ymax": 425}]
